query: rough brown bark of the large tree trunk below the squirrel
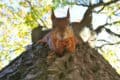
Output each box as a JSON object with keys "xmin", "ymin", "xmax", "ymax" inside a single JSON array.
[{"xmin": 0, "ymin": 43, "xmax": 120, "ymax": 80}]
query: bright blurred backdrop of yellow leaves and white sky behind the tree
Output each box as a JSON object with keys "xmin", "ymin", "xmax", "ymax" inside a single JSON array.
[{"xmin": 0, "ymin": 0, "xmax": 120, "ymax": 73}]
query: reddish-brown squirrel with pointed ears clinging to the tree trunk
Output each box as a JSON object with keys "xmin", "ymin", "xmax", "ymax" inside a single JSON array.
[{"xmin": 38, "ymin": 9, "xmax": 77, "ymax": 56}]
